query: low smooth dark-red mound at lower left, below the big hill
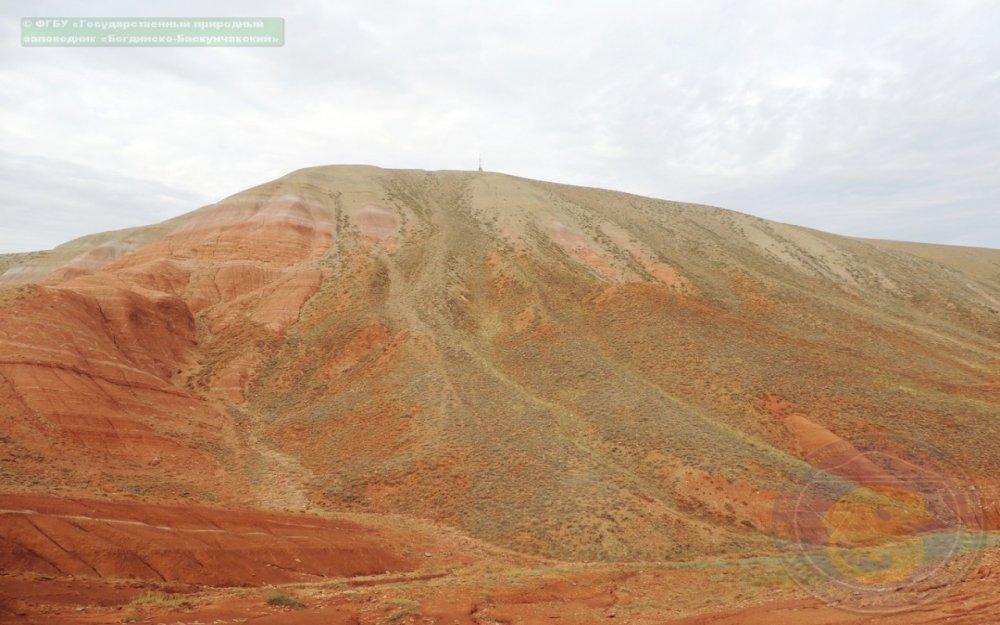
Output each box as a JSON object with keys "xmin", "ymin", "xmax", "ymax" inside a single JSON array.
[{"xmin": 0, "ymin": 495, "xmax": 419, "ymax": 586}]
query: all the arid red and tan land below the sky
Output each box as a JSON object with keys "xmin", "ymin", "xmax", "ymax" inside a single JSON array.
[{"xmin": 0, "ymin": 166, "xmax": 1000, "ymax": 625}]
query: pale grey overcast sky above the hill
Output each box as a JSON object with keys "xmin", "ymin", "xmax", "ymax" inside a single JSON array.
[{"xmin": 0, "ymin": 0, "xmax": 1000, "ymax": 252}]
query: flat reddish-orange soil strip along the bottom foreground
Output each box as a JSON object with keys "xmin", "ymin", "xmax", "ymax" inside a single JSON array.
[{"xmin": 0, "ymin": 540, "xmax": 1000, "ymax": 625}]
